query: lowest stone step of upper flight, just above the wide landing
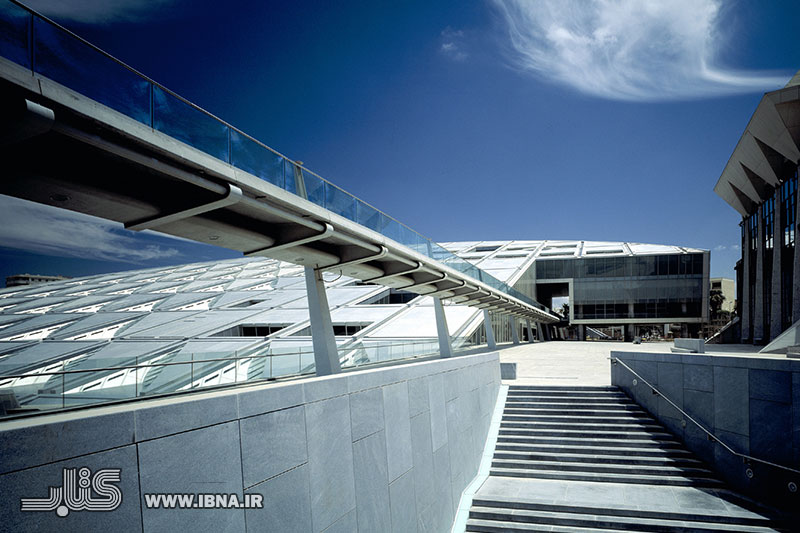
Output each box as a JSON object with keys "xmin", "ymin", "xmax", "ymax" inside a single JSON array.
[{"xmin": 492, "ymin": 458, "xmax": 715, "ymax": 478}]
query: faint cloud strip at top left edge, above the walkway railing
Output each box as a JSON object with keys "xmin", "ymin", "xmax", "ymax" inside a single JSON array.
[{"xmin": 23, "ymin": 0, "xmax": 174, "ymax": 24}]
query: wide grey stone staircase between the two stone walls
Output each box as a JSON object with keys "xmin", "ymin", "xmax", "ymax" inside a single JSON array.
[{"xmin": 466, "ymin": 386, "xmax": 792, "ymax": 532}]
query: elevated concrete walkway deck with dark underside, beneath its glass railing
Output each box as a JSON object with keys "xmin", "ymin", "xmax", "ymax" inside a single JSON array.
[{"xmin": 0, "ymin": 58, "xmax": 556, "ymax": 323}]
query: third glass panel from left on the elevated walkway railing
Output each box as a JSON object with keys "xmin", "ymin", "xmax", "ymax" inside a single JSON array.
[{"xmin": 153, "ymin": 87, "xmax": 229, "ymax": 162}]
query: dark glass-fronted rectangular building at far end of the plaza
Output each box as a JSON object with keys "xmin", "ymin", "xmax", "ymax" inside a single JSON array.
[{"xmin": 504, "ymin": 241, "xmax": 710, "ymax": 340}]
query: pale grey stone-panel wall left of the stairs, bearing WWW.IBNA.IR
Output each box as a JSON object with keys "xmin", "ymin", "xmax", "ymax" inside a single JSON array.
[{"xmin": 0, "ymin": 352, "xmax": 500, "ymax": 533}]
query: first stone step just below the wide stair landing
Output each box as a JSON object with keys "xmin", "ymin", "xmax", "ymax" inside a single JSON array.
[{"xmin": 470, "ymin": 507, "xmax": 776, "ymax": 533}]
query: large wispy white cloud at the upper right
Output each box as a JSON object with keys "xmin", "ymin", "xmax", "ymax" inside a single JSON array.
[{"xmin": 492, "ymin": 0, "xmax": 788, "ymax": 101}]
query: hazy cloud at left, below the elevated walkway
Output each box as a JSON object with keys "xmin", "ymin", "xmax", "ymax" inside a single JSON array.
[{"xmin": 0, "ymin": 195, "xmax": 181, "ymax": 263}]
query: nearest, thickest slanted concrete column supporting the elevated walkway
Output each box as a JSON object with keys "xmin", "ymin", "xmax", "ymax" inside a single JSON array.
[{"xmin": 305, "ymin": 267, "xmax": 342, "ymax": 376}]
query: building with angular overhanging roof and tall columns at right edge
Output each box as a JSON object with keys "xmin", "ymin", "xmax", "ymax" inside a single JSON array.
[{"xmin": 714, "ymin": 73, "xmax": 800, "ymax": 344}]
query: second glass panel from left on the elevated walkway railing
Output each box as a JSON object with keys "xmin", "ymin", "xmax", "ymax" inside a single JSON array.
[{"xmin": 33, "ymin": 18, "xmax": 150, "ymax": 125}]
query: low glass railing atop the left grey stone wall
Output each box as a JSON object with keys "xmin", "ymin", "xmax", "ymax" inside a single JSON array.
[{"xmin": 0, "ymin": 339, "xmax": 450, "ymax": 418}]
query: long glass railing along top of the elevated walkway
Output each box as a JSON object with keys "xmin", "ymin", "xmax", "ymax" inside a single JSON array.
[{"xmin": 0, "ymin": 0, "xmax": 547, "ymax": 310}]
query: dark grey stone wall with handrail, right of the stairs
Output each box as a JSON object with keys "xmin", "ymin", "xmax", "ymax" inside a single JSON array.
[{"xmin": 611, "ymin": 352, "xmax": 800, "ymax": 505}]
